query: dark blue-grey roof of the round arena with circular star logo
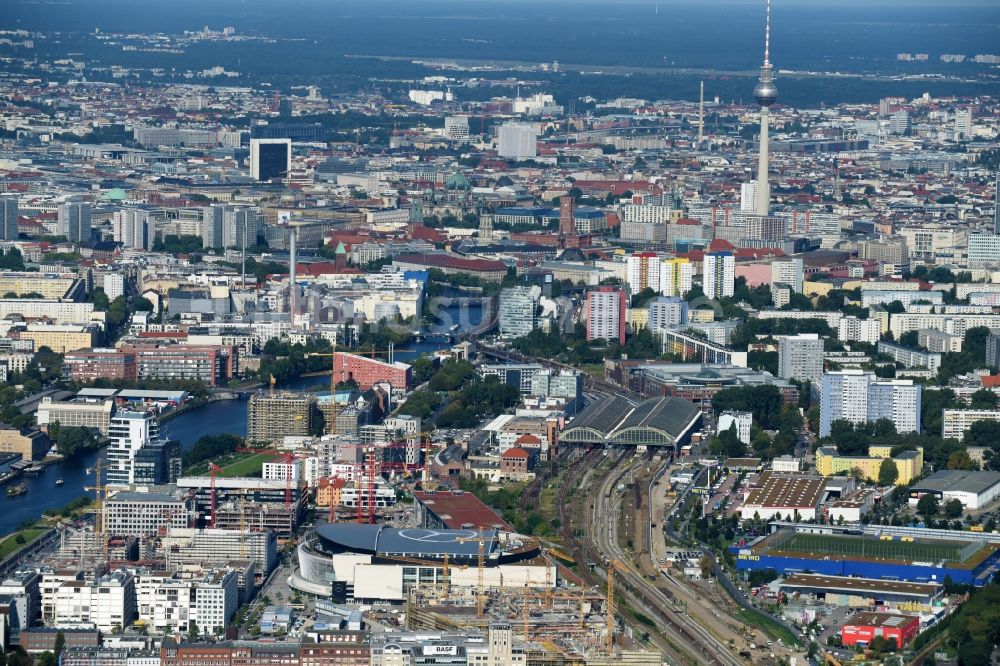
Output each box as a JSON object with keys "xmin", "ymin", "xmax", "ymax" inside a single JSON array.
[{"xmin": 316, "ymin": 523, "xmax": 499, "ymax": 560}]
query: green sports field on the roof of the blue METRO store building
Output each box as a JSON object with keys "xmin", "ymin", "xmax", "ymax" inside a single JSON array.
[{"xmin": 765, "ymin": 533, "xmax": 978, "ymax": 563}]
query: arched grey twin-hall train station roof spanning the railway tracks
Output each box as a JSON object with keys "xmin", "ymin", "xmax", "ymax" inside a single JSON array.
[{"xmin": 559, "ymin": 396, "xmax": 701, "ymax": 445}]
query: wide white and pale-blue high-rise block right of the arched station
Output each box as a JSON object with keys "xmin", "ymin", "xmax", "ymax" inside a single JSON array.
[{"xmin": 819, "ymin": 370, "xmax": 921, "ymax": 437}]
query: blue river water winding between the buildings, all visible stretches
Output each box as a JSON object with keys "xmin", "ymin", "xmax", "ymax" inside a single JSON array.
[{"xmin": 0, "ymin": 305, "xmax": 482, "ymax": 536}]
